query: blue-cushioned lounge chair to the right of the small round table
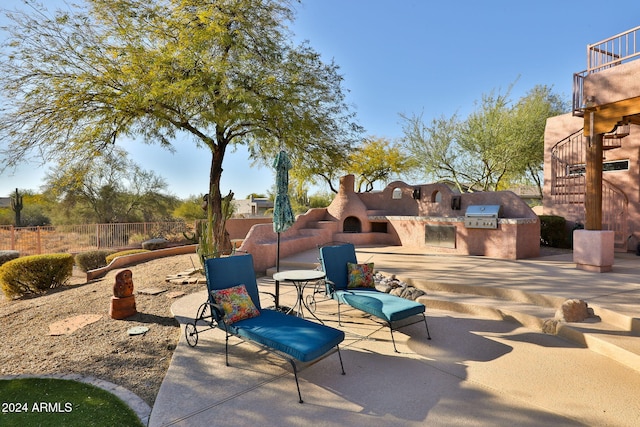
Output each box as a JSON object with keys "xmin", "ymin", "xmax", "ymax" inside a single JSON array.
[{"xmin": 320, "ymin": 243, "xmax": 431, "ymax": 353}]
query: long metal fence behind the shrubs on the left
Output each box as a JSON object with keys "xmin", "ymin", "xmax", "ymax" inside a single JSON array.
[{"xmin": 0, "ymin": 221, "xmax": 195, "ymax": 256}]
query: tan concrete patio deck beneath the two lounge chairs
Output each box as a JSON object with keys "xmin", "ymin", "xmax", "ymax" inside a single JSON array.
[{"xmin": 149, "ymin": 247, "xmax": 640, "ymax": 427}]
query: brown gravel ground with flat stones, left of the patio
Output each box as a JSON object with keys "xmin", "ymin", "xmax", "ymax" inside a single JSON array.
[{"xmin": 0, "ymin": 254, "xmax": 205, "ymax": 406}]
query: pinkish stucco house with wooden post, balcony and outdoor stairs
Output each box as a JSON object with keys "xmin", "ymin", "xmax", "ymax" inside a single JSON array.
[{"xmin": 543, "ymin": 27, "xmax": 640, "ymax": 251}]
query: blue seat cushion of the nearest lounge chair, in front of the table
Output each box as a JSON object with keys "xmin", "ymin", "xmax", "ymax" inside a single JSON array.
[{"xmin": 231, "ymin": 309, "xmax": 344, "ymax": 362}]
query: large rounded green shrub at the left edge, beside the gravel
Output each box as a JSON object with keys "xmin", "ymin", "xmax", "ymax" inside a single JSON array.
[{"xmin": 0, "ymin": 254, "xmax": 73, "ymax": 298}]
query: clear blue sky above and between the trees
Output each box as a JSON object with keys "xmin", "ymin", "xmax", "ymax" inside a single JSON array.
[{"xmin": 0, "ymin": 0, "xmax": 640, "ymax": 198}]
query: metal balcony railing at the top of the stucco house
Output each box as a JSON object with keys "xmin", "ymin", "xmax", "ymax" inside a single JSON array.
[{"xmin": 573, "ymin": 27, "xmax": 640, "ymax": 117}]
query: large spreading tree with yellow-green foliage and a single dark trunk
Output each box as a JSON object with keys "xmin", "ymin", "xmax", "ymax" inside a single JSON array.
[{"xmin": 0, "ymin": 0, "xmax": 359, "ymax": 254}]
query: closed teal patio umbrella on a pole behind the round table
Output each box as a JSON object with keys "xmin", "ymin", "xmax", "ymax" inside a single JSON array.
[{"xmin": 273, "ymin": 151, "xmax": 296, "ymax": 310}]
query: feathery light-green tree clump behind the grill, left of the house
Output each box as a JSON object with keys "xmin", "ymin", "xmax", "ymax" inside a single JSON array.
[{"xmin": 402, "ymin": 86, "xmax": 566, "ymax": 191}]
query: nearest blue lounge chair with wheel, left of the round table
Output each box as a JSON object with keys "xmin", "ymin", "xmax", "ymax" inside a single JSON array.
[{"xmin": 185, "ymin": 254, "xmax": 345, "ymax": 403}]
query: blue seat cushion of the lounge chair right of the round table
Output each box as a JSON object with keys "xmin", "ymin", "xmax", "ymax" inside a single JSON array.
[{"xmin": 335, "ymin": 289, "xmax": 425, "ymax": 322}]
